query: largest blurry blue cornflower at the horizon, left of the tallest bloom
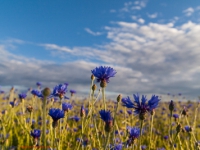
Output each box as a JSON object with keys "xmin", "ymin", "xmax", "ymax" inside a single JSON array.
[{"xmin": 53, "ymin": 84, "xmax": 67, "ymax": 99}]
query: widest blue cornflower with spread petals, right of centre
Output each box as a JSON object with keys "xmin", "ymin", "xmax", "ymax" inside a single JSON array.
[{"xmin": 122, "ymin": 94, "xmax": 160, "ymax": 120}]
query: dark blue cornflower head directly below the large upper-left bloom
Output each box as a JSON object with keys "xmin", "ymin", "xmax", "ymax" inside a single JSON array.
[{"xmin": 49, "ymin": 108, "xmax": 65, "ymax": 128}]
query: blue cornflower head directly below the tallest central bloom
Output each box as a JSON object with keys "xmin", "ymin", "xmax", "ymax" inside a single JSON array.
[{"xmin": 99, "ymin": 110, "xmax": 113, "ymax": 132}]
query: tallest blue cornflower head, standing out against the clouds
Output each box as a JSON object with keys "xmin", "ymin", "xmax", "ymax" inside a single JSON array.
[{"xmin": 91, "ymin": 66, "xmax": 117, "ymax": 88}]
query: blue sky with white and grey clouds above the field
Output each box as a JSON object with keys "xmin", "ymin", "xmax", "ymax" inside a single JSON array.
[{"xmin": 0, "ymin": 0, "xmax": 200, "ymax": 98}]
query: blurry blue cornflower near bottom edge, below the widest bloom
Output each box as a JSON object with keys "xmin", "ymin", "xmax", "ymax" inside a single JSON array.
[{"xmin": 127, "ymin": 127, "xmax": 140, "ymax": 146}]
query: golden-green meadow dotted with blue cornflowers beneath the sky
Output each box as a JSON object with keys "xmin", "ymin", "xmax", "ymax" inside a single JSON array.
[{"xmin": 0, "ymin": 66, "xmax": 200, "ymax": 150}]
